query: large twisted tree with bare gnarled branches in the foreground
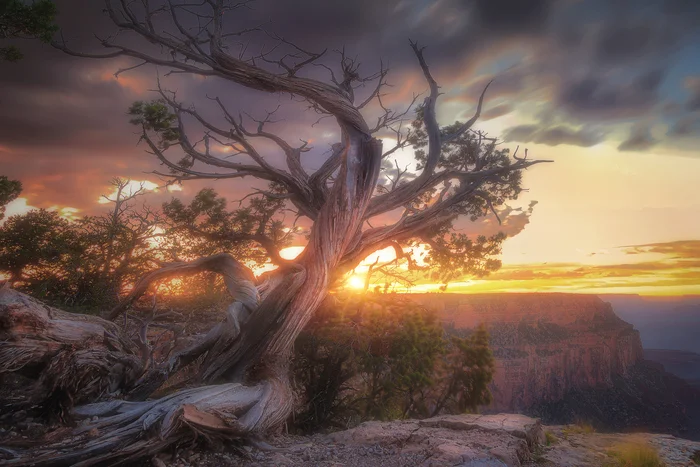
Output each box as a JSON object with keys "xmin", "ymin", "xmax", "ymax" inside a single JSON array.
[{"xmin": 4, "ymin": 0, "xmax": 539, "ymax": 464}]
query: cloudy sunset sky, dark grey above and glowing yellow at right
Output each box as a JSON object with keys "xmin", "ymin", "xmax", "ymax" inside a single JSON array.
[{"xmin": 0, "ymin": 0, "xmax": 700, "ymax": 295}]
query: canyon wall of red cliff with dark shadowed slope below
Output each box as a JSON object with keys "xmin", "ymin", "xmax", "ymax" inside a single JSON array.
[{"xmin": 411, "ymin": 293, "xmax": 700, "ymax": 439}]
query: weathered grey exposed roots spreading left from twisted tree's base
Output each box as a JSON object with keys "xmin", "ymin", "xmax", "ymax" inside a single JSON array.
[{"xmin": 7, "ymin": 378, "xmax": 291, "ymax": 466}]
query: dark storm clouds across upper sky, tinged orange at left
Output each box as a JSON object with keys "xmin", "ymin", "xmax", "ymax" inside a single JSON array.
[{"xmin": 0, "ymin": 0, "xmax": 700, "ymax": 214}]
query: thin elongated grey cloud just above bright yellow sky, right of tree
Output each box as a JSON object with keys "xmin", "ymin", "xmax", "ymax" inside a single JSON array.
[{"xmin": 503, "ymin": 125, "xmax": 605, "ymax": 147}]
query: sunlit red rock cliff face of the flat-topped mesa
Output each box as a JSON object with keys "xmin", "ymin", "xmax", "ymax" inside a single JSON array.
[{"xmin": 413, "ymin": 294, "xmax": 643, "ymax": 411}]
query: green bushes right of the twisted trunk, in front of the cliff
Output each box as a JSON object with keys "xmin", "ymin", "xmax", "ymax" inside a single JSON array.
[{"xmin": 294, "ymin": 294, "xmax": 494, "ymax": 431}]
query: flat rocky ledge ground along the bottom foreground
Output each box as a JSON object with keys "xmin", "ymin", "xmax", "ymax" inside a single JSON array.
[{"xmin": 152, "ymin": 415, "xmax": 700, "ymax": 467}]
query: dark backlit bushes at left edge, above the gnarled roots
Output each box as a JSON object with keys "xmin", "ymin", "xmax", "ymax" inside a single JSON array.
[{"xmin": 0, "ymin": 180, "xmax": 158, "ymax": 308}]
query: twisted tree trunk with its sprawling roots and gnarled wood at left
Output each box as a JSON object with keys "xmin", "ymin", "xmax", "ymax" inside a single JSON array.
[{"xmin": 0, "ymin": 132, "xmax": 381, "ymax": 466}]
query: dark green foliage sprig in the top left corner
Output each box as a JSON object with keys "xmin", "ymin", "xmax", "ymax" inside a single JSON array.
[{"xmin": 0, "ymin": 0, "xmax": 58, "ymax": 62}]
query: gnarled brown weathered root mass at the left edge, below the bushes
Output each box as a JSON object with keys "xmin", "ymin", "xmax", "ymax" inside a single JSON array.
[{"xmin": 0, "ymin": 288, "xmax": 142, "ymax": 412}]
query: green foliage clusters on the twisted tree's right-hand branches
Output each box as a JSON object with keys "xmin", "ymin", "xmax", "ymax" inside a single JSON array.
[{"xmin": 372, "ymin": 107, "xmax": 522, "ymax": 288}]
